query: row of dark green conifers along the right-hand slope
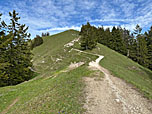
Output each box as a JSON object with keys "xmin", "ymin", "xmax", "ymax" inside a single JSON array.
[{"xmin": 80, "ymin": 22, "xmax": 152, "ymax": 70}]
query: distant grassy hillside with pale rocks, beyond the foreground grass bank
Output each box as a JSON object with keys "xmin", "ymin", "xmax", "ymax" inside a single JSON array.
[{"xmin": 33, "ymin": 30, "xmax": 95, "ymax": 77}]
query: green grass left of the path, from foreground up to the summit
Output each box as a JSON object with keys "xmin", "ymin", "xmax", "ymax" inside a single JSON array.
[{"xmin": 0, "ymin": 30, "xmax": 96, "ymax": 114}]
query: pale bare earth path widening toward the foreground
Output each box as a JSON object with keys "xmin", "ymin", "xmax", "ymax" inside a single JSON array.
[{"xmin": 81, "ymin": 50, "xmax": 152, "ymax": 114}]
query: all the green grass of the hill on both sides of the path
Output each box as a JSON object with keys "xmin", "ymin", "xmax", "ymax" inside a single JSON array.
[{"xmin": 0, "ymin": 30, "xmax": 152, "ymax": 114}]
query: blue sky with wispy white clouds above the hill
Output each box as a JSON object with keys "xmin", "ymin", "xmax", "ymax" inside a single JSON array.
[{"xmin": 0, "ymin": 0, "xmax": 152, "ymax": 37}]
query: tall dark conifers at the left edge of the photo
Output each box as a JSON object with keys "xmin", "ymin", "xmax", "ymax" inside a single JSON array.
[{"xmin": 0, "ymin": 10, "xmax": 34, "ymax": 86}]
